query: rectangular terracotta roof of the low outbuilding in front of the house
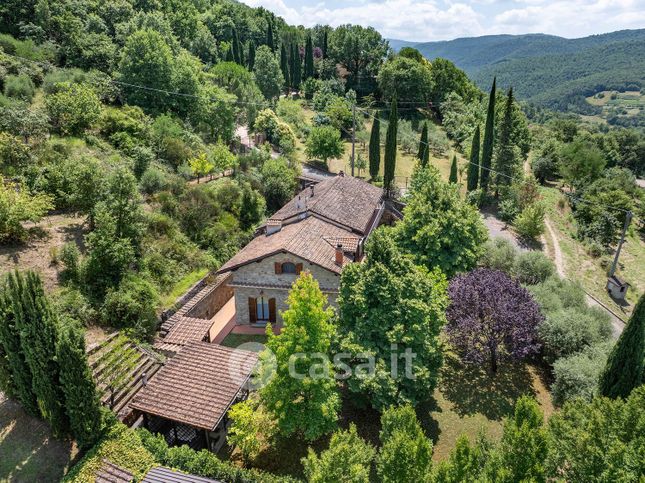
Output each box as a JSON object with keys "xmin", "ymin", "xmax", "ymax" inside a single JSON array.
[{"xmin": 130, "ymin": 342, "xmax": 257, "ymax": 431}]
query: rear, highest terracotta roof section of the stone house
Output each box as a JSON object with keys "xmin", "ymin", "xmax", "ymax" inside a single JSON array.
[{"xmin": 271, "ymin": 176, "xmax": 383, "ymax": 235}]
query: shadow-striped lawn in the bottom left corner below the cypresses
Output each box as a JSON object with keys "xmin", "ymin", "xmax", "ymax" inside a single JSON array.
[{"xmin": 0, "ymin": 393, "xmax": 77, "ymax": 483}]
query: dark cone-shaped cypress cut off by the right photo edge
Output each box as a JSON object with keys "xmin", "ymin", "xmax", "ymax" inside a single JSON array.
[{"xmin": 600, "ymin": 294, "xmax": 645, "ymax": 398}]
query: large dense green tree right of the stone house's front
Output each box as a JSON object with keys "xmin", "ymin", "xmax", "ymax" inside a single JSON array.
[{"xmin": 338, "ymin": 230, "xmax": 447, "ymax": 409}]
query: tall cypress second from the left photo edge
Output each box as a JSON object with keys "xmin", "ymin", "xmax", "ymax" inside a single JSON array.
[{"xmin": 9, "ymin": 271, "xmax": 69, "ymax": 436}]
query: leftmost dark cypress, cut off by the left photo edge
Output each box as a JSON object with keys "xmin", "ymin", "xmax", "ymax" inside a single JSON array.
[{"xmin": 0, "ymin": 281, "xmax": 40, "ymax": 416}]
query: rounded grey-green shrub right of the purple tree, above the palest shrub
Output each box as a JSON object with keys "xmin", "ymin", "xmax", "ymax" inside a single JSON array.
[{"xmin": 538, "ymin": 308, "xmax": 611, "ymax": 364}]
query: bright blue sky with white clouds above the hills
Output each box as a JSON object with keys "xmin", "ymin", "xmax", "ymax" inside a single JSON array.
[{"xmin": 242, "ymin": 0, "xmax": 645, "ymax": 42}]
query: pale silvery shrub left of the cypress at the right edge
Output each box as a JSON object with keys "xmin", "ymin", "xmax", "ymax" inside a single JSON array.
[{"xmin": 551, "ymin": 343, "xmax": 611, "ymax": 406}]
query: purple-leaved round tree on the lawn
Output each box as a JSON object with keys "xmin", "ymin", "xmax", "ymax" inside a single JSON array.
[{"xmin": 446, "ymin": 268, "xmax": 543, "ymax": 373}]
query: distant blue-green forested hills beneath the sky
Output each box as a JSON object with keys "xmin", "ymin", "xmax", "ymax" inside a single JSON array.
[{"xmin": 390, "ymin": 29, "xmax": 645, "ymax": 111}]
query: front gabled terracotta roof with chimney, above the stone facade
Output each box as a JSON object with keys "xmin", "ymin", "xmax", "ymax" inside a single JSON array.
[{"xmin": 219, "ymin": 216, "xmax": 360, "ymax": 273}]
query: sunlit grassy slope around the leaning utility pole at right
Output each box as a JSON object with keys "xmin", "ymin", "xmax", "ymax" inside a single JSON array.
[{"xmin": 541, "ymin": 188, "xmax": 645, "ymax": 319}]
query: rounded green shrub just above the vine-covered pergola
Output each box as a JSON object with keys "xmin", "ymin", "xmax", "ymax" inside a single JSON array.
[{"xmin": 101, "ymin": 275, "xmax": 159, "ymax": 339}]
